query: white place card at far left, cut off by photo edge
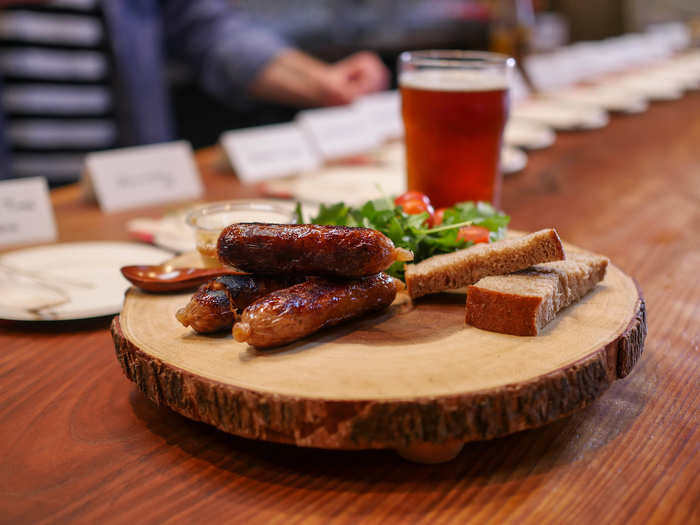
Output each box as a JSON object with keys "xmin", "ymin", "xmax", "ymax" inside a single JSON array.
[{"xmin": 0, "ymin": 177, "xmax": 56, "ymax": 246}]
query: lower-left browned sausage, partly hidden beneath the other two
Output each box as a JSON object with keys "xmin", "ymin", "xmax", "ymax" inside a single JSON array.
[{"xmin": 175, "ymin": 275, "xmax": 303, "ymax": 334}]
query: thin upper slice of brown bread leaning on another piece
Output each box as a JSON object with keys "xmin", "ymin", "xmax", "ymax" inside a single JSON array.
[{"xmin": 406, "ymin": 229, "xmax": 564, "ymax": 299}]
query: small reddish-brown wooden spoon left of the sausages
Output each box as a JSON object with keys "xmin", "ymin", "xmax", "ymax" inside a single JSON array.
[{"xmin": 121, "ymin": 265, "xmax": 244, "ymax": 293}]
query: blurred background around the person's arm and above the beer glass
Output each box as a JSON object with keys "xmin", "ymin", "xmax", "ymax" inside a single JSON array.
[{"xmin": 171, "ymin": 0, "xmax": 700, "ymax": 147}]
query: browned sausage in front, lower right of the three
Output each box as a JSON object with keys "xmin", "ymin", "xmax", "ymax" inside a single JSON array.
[{"xmin": 233, "ymin": 273, "xmax": 402, "ymax": 348}]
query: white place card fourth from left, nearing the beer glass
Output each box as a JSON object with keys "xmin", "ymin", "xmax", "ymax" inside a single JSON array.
[{"xmin": 297, "ymin": 106, "xmax": 381, "ymax": 159}]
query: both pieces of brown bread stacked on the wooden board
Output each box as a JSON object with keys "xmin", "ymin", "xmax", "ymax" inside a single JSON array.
[{"xmin": 405, "ymin": 229, "xmax": 608, "ymax": 335}]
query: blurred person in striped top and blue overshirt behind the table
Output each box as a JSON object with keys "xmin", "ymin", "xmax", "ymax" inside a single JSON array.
[{"xmin": 0, "ymin": 0, "xmax": 389, "ymax": 185}]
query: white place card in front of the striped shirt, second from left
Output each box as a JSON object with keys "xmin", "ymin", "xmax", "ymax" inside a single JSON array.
[{"xmin": 85, "ymin": 141, "xmax": 203, "ymax": 212}]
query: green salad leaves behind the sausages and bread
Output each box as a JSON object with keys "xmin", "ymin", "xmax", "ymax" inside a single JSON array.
[{"xmin": 295, "ymin": 197, "xmax": 510, "ymax": 279}]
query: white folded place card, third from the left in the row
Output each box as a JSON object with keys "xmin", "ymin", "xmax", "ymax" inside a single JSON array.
[{"xmin": 219, "ymin": 123, "xmax": 321, "ymax": 182}]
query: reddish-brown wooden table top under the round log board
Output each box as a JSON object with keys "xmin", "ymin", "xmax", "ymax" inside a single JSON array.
[{"xmin": 0, "ymin": 92, "xmax": 700, "ymax": 524}]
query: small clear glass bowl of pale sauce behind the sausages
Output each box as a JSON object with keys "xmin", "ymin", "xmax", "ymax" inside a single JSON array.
[{"xmin": 186, "ymin": 201, "xmax": 293, "ymax": 268}]
